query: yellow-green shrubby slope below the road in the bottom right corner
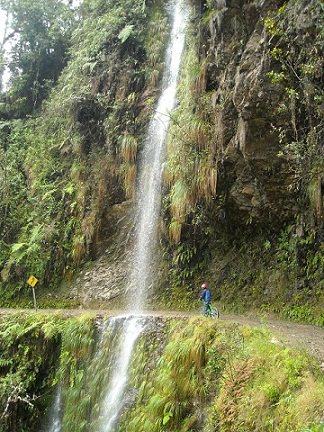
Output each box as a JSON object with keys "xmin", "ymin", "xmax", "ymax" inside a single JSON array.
[{"xmin": 206, "ymin": 329, "xmax": 324, "ymax": 431}]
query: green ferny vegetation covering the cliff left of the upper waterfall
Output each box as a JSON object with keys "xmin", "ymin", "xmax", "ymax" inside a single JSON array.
[{"xmin": 0, "ymin": 0, "xmax": 167, "ymax": 301}]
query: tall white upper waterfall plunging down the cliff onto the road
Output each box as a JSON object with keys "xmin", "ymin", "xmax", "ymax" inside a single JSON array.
[{"xmin": 128, "ymin": 0, "xmax": 186, "ymax": 312}]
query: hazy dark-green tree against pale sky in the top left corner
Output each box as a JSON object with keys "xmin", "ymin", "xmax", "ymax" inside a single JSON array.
[{"xmin": 0, "ymin": 0, "xmax": 75, "ymax": 117}]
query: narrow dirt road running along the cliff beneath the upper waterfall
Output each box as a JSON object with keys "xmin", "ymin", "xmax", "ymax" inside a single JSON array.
[{"xmin": 0, "ymin": 309, "xmax": 324, "ymax": 364}]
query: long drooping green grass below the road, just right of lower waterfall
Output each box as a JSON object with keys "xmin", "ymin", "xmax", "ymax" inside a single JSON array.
[{"xmin": 121, "ymin": 323, "xmax": 208, "ymax": 432}]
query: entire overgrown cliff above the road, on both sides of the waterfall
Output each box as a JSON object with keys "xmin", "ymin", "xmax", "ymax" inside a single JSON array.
[{"xmin": 0, "ymin": 0, "xmax": 324, "ymax": 324}]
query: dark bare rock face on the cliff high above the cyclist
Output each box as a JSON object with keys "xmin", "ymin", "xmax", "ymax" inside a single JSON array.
[{"xmin": 203, "ymin": 0, "xmax": 316, "ymax": 230}]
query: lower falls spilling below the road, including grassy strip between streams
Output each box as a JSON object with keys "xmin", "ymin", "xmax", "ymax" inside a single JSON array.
[{"xmin": 42, "ymin": 315, "xmax": 149, "ymax": 432}]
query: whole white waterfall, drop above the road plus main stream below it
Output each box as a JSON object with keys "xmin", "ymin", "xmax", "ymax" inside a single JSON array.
[{"xmin": 95, "ymin": 0, "xmax": 186, "ymax": 432}]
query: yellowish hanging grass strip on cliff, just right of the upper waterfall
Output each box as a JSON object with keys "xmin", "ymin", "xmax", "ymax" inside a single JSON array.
[{"xmin": 164, "ymin": 28, "xmax": 217, "ymax": 243}]
